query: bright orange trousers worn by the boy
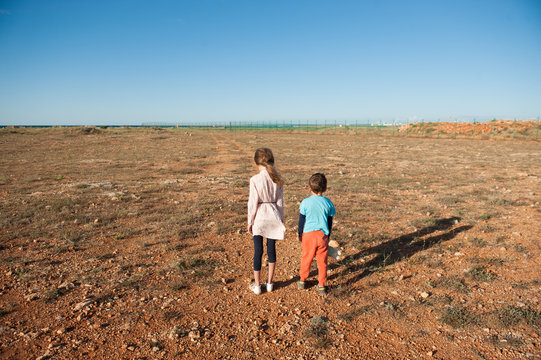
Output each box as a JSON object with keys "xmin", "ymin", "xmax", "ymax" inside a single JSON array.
[{"xmin": 299, "ymin": 230, "xmax": 329, "ymax": 286}]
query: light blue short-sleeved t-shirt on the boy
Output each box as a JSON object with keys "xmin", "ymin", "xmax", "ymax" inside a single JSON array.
[{"xmin": 299, "ymin": 195, "xmax": 336, "ymax": 235}]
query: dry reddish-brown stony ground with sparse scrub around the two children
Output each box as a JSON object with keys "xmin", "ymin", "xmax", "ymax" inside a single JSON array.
[{"xmin": 0, "ymin": 128, "xmax": 541, "ymax": 360}]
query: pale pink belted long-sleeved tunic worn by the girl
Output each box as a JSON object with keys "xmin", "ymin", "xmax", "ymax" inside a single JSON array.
[{"xmin": 248, "ymin": 169, "xmax": 286, "ymax": 240}]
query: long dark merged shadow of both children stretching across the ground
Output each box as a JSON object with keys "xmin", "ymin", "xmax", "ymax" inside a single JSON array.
[{"xmin": 279, "ymin": 217, "xmax": 473, "ymax": 287}]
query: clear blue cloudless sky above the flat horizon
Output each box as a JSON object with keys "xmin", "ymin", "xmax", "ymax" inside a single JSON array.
[{"xmin": 0, "ymin": 0, "xmax": 541, "ymax": 125}]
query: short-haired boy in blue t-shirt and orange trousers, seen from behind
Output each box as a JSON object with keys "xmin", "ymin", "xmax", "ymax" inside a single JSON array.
[{"xmin": 297, "ymin": 173, "xmax": 336, "ymax": 294}]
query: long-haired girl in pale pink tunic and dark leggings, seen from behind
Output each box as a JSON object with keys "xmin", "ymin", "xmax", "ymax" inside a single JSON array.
[{"xmin": 247, "ymin": 148, "xmax": 286, "ymax": 294}]
